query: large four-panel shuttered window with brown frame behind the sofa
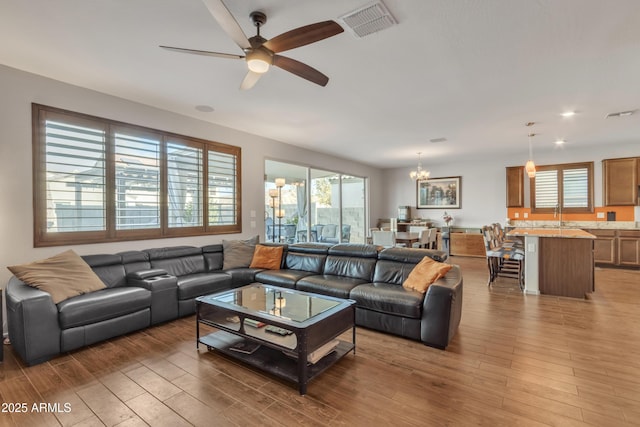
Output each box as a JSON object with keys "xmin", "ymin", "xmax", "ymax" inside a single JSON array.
[{"xmin": 32, "ymin": 104, "xmax": 242, "ymax": 247}]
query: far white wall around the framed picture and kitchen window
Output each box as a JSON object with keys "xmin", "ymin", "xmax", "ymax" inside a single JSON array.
[{"xmin": 382, "ymin": 142, "xmax": 640, "ymax": 227}]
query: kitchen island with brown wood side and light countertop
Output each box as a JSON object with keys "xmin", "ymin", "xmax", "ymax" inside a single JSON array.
[{"xmin": 507, "ymin": 228, "xmax": 596, "ymax": 298}]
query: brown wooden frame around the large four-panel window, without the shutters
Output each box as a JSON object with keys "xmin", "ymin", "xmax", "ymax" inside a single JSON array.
[{"xmin": 32, "ymin": 103, "xmax": 242, "ymax": 247}]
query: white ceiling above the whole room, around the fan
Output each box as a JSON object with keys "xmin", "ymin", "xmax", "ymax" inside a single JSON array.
[{"xmin": 0, "ymin": 0, "xmax": 640, "ymax": 168}]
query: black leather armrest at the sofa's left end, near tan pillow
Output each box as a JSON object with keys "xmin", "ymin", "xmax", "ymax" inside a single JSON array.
[{"xmin": 6, "ymin": 277, "xmax": 60, "ymax": 365}]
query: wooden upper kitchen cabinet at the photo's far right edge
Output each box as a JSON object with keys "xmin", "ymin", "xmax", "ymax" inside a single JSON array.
[{"xmin": 602, "ymin": 157, "xmax": 640, "ymax": 206}]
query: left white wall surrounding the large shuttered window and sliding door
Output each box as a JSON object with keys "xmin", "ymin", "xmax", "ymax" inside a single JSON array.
[{"xmin": 0, "ymin": 66, "xmax": 381, "ymax": 288}]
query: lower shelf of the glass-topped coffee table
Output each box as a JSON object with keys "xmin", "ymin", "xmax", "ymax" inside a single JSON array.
[{"xmin": 200, "ymin": 331, "xmax": 355, "ymax": 394}]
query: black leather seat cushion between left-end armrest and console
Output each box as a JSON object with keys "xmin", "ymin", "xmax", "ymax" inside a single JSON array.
[{"xmin": 58, "ymin": 286, "xmax": 151, "ymax": 329}]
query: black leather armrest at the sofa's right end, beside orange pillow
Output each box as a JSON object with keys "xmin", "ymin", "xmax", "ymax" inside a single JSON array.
[{"xmin": 420, "ymin": 265, "xmax": 462, "ymax": 350}]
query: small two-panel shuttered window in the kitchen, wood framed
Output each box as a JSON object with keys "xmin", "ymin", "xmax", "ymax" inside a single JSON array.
[{"xmin": 531, "ymin": 162, "xmax": 593, "ymax": 213}]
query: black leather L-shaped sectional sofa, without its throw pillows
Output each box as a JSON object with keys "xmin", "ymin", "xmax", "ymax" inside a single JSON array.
[{"xmin": 6, "ymin": 243, "xmax": 462, "ymax": 365}]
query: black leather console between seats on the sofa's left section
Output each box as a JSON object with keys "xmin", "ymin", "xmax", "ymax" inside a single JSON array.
[{"xmin": 127, "ymin": 269, "xmax": 178, "ymax": 325}]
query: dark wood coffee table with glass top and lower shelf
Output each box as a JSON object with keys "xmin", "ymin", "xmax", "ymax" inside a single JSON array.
[{"xmin": 196, "ymin": 283, "xmax": 356, "ymax": 394}]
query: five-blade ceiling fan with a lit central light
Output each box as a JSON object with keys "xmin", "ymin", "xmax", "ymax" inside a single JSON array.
[{"xmin": 160, "ymin": 0, "xmax": 344, "ymax": 89}]
